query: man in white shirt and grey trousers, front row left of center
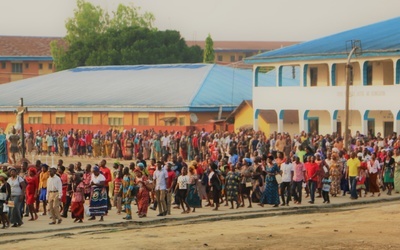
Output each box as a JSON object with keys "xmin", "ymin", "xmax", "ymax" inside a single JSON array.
[{"xmin": 153, "ymin": 161, "xmax": 168, "ymax": 216}]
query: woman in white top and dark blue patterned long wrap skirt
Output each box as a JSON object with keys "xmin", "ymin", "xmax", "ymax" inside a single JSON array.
[{"xmin": 89, "ymin": 165, "xmax": 107, "ymax": 221}]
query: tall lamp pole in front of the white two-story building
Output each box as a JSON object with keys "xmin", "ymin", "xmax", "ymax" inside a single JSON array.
[{"xmin": 344, "ymin": 40, "xmax": 361, "ymax": 152}]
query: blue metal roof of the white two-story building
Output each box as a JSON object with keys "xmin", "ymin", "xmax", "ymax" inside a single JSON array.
[{"xmin": 245, "ymin": 17, "xmax": 400, "ymax": 63}]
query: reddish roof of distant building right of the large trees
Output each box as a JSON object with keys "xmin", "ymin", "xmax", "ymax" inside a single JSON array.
[{"xmin": 186, "ymin": 41, "xmax": 300, "ymax": 51}]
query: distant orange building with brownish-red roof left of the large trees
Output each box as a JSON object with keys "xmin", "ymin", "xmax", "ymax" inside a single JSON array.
[{"xmin": 0, "ymin": 36, "xmax": 62, "ymax": 84}]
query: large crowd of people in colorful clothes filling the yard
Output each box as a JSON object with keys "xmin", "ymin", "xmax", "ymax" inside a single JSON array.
[{"xmin": 0, "ymin": 127, "xmax": 400, "ymax": 228}]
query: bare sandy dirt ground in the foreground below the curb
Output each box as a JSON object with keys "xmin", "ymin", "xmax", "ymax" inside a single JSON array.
[{"xmin": 1, "ymin": 201, "xmax": 400, "ymax": 249}]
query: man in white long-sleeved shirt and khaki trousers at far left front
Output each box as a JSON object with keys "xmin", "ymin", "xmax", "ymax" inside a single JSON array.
[{"xmin": 46, "ymin": 166, "xmax": 62, "ymax": 225}]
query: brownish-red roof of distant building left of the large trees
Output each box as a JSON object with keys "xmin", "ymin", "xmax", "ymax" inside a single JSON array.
[{"xmin": 0, "ymin": 36, "xmax": 63, "ymax": 57}]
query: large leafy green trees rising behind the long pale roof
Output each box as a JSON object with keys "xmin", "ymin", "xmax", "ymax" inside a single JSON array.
[{"xmin": 51, "ymin": 0, "xmax": 202, "ymax": 70}]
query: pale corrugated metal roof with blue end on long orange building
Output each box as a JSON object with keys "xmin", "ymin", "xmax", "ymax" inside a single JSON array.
[{"xmin": 0, "ymin": 64, "xmax": 252, "ymax": 111}]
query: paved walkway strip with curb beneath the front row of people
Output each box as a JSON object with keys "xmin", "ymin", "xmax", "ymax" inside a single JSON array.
[{"xmin": 0, "ymin": 190, "xmax": 400, "ymax": 238}]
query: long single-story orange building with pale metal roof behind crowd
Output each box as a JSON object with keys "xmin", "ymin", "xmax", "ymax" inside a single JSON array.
[{"xmin": 0, "ymin": 64, "xmax": 252, "ymax": 131}]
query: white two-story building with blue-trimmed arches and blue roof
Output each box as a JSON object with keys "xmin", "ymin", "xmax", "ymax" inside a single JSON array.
[{"xmin": 245, "ymin": 18, "xmax": 400, "ymax": 138}]
